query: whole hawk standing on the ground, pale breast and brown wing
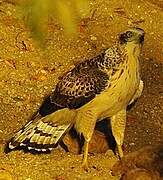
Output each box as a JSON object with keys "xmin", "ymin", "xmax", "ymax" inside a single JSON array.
[{"xmin": 8, "ymin": 28, "xmax": 144, "ymax": 168}]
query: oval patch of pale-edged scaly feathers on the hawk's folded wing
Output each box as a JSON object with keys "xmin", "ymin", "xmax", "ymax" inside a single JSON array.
[{"xmin": 51, "ymin": 68, "xmax": 109, "ymax": 109}]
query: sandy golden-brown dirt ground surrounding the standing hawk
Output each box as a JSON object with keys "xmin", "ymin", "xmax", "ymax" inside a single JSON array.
[{"xmin": 0, "ymin": 0, "xmax": 163, "ymax": 180}]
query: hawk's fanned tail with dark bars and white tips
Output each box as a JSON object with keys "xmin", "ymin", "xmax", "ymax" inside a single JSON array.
[{"xmin": 9, "ymin": 108, "xmax": 75, "ymax": 151}]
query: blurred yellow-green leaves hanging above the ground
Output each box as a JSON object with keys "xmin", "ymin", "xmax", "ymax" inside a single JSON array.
[{"xmin": 18, "ymin": 0, "xmax": 89, "ymax": 42}]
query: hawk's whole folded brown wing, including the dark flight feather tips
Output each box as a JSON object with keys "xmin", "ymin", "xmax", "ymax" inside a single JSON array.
[{"xmin": 40, "ymin": 56, "xmax": 109, "ymax": 116}]
